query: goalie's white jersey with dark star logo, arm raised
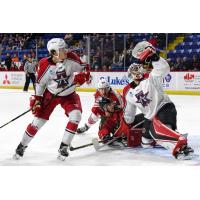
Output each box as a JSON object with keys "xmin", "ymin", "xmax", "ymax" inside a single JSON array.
[{"xmin": 124, "ymin": 57, "xmax": 171, "ymax": 124}]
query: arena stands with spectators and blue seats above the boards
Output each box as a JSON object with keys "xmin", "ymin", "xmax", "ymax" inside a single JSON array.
[{"xmin": 0, "ymin": 33, "xmax": 200, "ymax": 71}]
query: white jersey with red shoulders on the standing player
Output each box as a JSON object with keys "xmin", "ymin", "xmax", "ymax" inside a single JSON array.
[{"xmin": 36, "ymin": 52, "xmax": 86, "ymax": 96}]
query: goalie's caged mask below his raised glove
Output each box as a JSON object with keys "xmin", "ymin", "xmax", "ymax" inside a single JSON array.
[{"xmin": 128, "ymin": 63, "xmax": 144, "ymax": 81}]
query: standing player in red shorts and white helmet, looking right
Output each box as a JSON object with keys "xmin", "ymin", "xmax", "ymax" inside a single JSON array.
[{"xmin": 14, "ymin": 38, "xmax": 90, "ymax": 160}]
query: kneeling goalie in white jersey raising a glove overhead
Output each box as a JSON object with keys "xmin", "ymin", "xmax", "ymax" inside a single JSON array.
[{"xmin": 115, "ymin": 41, "xmax": 194, "ymax": 159}]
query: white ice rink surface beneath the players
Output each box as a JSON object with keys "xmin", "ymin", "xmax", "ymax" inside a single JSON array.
[{"xmin": 0, "ymin": 89, "xmax": 200, "ymax": 166}]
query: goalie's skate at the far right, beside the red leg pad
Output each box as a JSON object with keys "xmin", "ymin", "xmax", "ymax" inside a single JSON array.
[{"xmin": 175, "ymin": 145, "xmax": 197, "ymax": 160}]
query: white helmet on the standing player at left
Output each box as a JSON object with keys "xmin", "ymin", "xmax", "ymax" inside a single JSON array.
[{"xmin": 47, "ymin": 38, "xmax": 67, "ymax": 54}]
